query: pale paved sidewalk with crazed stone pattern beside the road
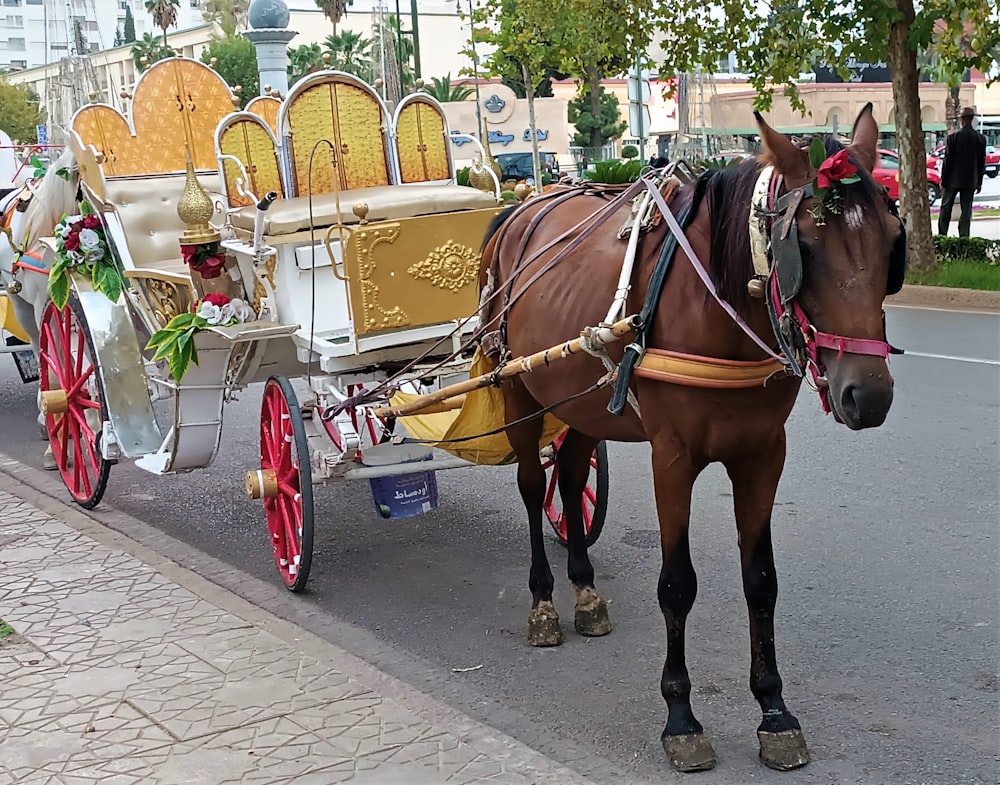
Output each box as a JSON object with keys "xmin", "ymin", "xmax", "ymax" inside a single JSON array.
[{"xmin": 0, "ymin": 474, "xmax": 600, "ymax": 785}]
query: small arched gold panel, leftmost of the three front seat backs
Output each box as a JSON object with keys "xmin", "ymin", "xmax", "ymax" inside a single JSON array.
[{"xmin": 219, "ymin": 114, "xmax": 283, "ymax": 207}]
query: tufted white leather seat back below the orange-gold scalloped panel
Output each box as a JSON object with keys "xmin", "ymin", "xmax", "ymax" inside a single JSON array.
[{"xmin": 104, "ymin": 172, "xmax": 221, "ymax": 274}]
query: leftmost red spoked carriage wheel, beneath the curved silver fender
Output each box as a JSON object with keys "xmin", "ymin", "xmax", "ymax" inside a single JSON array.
[{"xmin": 38, "ymin": 296, "xmax": 113, "ymax": 510}]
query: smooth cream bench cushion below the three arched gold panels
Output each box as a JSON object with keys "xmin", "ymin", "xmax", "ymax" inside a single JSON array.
[{"xmin": 230, "ymin": 184, "xmax": 497, "ymax": 236}]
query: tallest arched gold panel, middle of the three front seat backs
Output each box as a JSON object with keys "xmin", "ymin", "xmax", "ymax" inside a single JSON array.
[{"xmin": 282, "ymin": 75, "xmax": 391, "ymax": 196}]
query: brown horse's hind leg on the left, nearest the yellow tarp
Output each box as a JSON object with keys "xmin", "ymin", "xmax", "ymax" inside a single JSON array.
[{"xmin": 504, "ymin": 379, "xmax": 563, "ymax": 646}]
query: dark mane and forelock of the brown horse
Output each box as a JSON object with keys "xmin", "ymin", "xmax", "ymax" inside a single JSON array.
[{"xmin": 698, "ymin": 136, "xmax": 880, "ymax": 310}]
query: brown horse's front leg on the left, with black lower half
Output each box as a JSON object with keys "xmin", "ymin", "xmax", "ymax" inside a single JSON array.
[{"xmin": 653, "ymin": 436, "xmax": 716, "ymax": 771}]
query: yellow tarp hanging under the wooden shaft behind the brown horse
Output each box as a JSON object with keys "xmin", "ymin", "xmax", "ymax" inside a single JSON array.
[{"xmin": 392, "ymin": 349, "xmax": 566, "ymax": 466}]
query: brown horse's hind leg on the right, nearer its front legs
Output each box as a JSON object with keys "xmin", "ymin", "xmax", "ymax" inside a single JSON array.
[{"xmin": 558, "ymin": 429, "xmax": 611, "ymax": 637}]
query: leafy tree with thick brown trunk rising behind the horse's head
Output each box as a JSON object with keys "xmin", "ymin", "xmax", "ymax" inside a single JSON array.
[{"xmin": 652, "ymin": 0, "xmax": 1000, "ymax": 270}]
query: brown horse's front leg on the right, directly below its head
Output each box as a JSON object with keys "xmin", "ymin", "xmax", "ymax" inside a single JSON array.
[{"xmin": 726, "ymin": 431, "xmax": 809, "ymax": 770}]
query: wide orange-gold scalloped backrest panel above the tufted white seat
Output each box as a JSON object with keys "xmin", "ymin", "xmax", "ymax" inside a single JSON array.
[{"xmin": 72, "ymin": 58, "xmax": 233, "ymax": 176}]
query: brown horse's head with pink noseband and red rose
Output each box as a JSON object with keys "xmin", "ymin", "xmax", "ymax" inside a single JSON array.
[{"xmin": 757, "ymin": 104, "xmax": 906, "ymax": 430}]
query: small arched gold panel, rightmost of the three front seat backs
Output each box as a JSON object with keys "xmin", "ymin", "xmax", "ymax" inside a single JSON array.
[{"xmin": 396, "ymin": 95, "xmax": 452, "ymax": 183}]
